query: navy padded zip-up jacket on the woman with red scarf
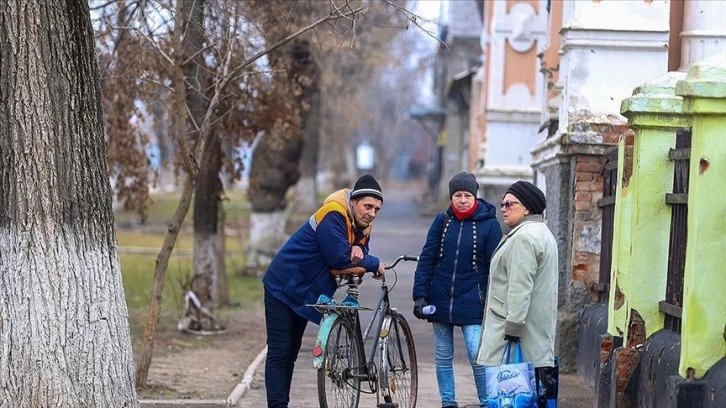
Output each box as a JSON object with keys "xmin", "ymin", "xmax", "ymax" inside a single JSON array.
[{"xmin": 413, "ymin": 198, "xmax": 502, "ymax": 325}]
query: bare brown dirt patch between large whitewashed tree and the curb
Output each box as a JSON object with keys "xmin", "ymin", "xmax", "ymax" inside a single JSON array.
[{"xmin": 137, "ymin": 308, "xmax": 266, "ymax": 399}]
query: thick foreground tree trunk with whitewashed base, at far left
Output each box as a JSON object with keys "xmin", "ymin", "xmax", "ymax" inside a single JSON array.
[{"xmin": 0, "ymin": 0, "xmax": 138, "ymax": 407}]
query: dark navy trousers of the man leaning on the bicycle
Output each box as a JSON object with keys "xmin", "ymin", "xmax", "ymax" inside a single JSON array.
[{"xmin": 265, "ymin": 288, "xmax": 308, "ymax": 408}]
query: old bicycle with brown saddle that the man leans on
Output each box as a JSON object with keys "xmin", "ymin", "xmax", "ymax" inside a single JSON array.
[{"xmin": 309, "ymin": 255, "xmax": 419, "ymax": 408}]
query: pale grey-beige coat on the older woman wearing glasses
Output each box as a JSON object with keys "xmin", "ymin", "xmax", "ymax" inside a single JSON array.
[{"xmin": 476, "ymin": 215, "xmax": 558, "ymax": 367}]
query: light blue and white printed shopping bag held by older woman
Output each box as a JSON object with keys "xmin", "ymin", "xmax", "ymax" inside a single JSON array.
[{"xmin": 485, "ymin": 342, "xmax": 537, "ymax": 408}]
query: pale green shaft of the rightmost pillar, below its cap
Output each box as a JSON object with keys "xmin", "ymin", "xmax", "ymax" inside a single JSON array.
[{"xmin": 678, "ymin": 119, "xmax": 726, "ymax": 378}]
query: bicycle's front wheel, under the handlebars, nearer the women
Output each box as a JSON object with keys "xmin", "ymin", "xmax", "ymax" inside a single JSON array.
[{"xmin": 379, "ymin": 313, "xmax": 418, "ymax": 408}]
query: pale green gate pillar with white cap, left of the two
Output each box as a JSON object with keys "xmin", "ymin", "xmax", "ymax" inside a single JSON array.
[{"xmin": 620, "ymin": 72, "xmax": 690, "ymax": 338}]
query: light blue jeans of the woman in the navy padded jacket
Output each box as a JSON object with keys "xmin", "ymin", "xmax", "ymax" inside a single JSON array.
[{"xmin": 433, "ymin": 322, "xmax": 487, "ymax": 407}]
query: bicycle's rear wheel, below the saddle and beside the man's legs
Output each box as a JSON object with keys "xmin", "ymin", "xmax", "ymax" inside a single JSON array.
[{"xmin": 318, "ymin": 317, "xmax": 365, "ymax": 408}]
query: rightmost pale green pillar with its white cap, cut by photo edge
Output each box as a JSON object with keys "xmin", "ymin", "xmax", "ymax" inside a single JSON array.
[{"xmin": 676, "ymin": 53, "xmax": 726, "ymax": 378}]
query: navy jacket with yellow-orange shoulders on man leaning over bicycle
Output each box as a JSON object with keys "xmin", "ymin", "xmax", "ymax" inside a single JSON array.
[{"xmin": 262, "ymin": 189, "xmax": 380, "ymax": 324}]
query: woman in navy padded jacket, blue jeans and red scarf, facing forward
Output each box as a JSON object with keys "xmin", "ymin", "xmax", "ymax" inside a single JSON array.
[{"xmin": 413, "ymin": 172, "xmax": 502, "ymax": 407}]
